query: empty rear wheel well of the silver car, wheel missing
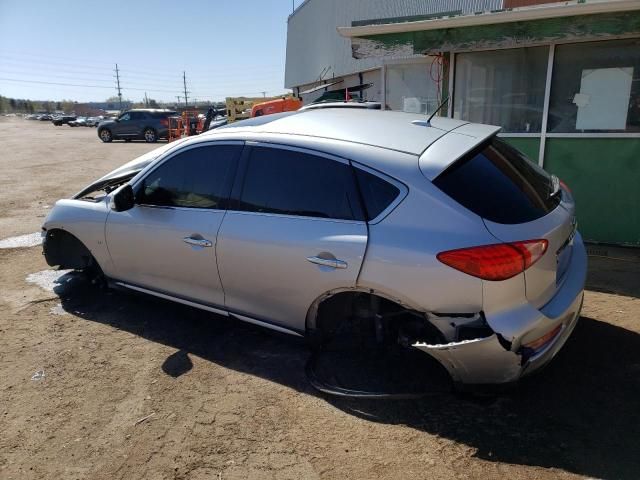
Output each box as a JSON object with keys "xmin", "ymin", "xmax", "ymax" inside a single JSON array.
[{"xmin": 306, "ymin": 290, "xmax": 444, "ymax": 347}]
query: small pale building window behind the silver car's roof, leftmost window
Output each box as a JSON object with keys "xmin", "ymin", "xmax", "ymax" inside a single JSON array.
[{"xmin": 385, "ymin": 63, "xmax": 440, "ymax": 113}]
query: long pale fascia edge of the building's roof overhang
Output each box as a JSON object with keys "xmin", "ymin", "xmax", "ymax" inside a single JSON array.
[{"xmin": 338, "ymin": 0, "xmax": 640, "ymax": 38}]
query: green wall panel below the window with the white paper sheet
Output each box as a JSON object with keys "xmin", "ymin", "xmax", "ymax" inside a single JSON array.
[{"xmin": 544, "ymin": 138, "xmax": 640, "ymax": 246}]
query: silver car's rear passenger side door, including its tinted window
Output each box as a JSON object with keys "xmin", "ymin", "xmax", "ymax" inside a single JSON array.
[{"xmin": 218, "ymin": 144, "xmax": 367, "ymax": 331}]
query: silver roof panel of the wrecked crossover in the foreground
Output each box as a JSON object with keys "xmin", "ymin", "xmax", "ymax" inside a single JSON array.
[{"xmin": 201, "ymin": 108, "xmax": 499, "ymax": 155}]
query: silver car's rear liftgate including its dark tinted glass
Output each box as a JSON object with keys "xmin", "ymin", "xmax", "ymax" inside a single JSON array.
[{"xmin": 434, "ymin": 137, "xmax": 576, "ymax": 307}]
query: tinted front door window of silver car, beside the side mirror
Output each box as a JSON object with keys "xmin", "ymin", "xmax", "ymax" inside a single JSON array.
[{"xmin": 136, "ymin": 145, "xmax": 242, "ymax": 209}]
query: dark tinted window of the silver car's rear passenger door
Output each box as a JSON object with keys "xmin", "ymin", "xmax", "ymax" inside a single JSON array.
[{"xmin": 238, "ymin": 147, "xmax": 364, "ymax": 220}]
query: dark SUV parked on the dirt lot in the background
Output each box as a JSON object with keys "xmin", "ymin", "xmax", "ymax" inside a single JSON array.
[{"xmin": 98, "ymin": 108, "xmax": 176, "ymax": 143}]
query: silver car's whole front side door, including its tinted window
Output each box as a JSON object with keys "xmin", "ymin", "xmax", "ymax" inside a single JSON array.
[{"xmin": 106, "ymin": 143, "xmax": 242, "ymax": 306}]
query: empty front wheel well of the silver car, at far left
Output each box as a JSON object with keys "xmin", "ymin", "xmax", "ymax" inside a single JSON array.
[{"xmin": 43, "ymin": 228, "xmax": 95, "ymax": 270}]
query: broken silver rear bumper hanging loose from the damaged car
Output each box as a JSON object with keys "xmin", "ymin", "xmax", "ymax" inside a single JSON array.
[{"xmin": 414, "ymin": 234, "xmax": 587, "ymax": 387}]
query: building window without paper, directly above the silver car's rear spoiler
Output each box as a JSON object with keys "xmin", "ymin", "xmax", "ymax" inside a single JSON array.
[{"xmin": 453, "ymin": 47, "xmax": 549, "ymax": 133}]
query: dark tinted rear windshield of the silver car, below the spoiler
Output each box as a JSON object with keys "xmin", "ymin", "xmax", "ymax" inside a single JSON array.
[{"xmin": 433, "ymin": 137, "xmax": 560, "ymax": 224}]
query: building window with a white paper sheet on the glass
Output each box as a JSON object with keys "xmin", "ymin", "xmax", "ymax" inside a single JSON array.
[{"xmin": 548, "ymin": 39, "xmax": 640, "ymax": 133}]
